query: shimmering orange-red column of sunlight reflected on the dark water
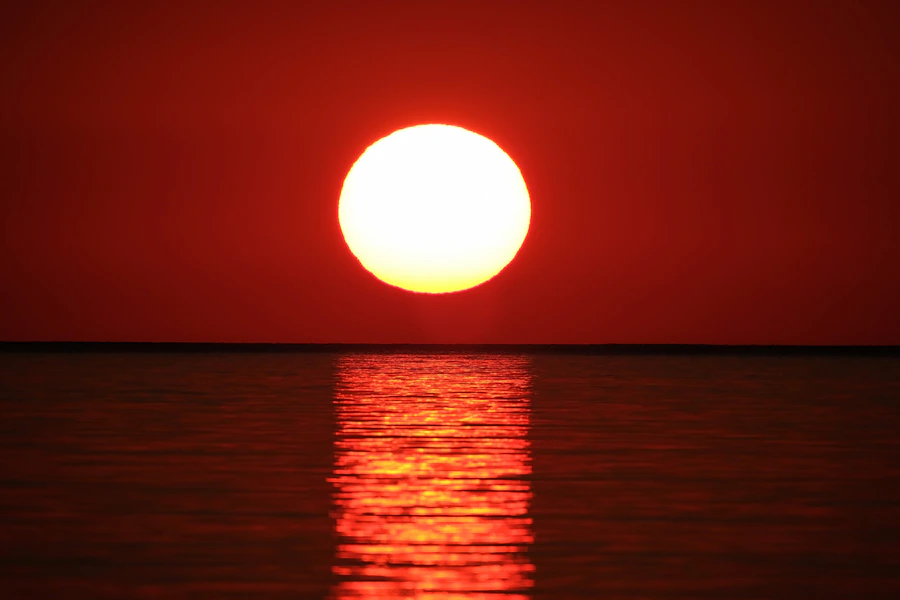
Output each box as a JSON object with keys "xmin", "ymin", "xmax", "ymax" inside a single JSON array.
[{"xmin": 331, "ymin": 354, "xmax": 534, "ymax": 600}]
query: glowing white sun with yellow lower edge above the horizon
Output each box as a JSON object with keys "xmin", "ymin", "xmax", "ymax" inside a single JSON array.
[{"xmin": 338, "ymin": 125, "xmax": 531, "ymax": 294}]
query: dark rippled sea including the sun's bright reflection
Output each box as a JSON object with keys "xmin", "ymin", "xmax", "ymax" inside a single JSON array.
[{"xmin": 0, "ymin": 351, "xmax": 900, "ymax": 600}]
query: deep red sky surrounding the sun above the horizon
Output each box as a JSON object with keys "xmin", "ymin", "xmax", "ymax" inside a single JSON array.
[{"xmin": 0, "ymin": 1, "xmax": 900, "ymax": 344}]
